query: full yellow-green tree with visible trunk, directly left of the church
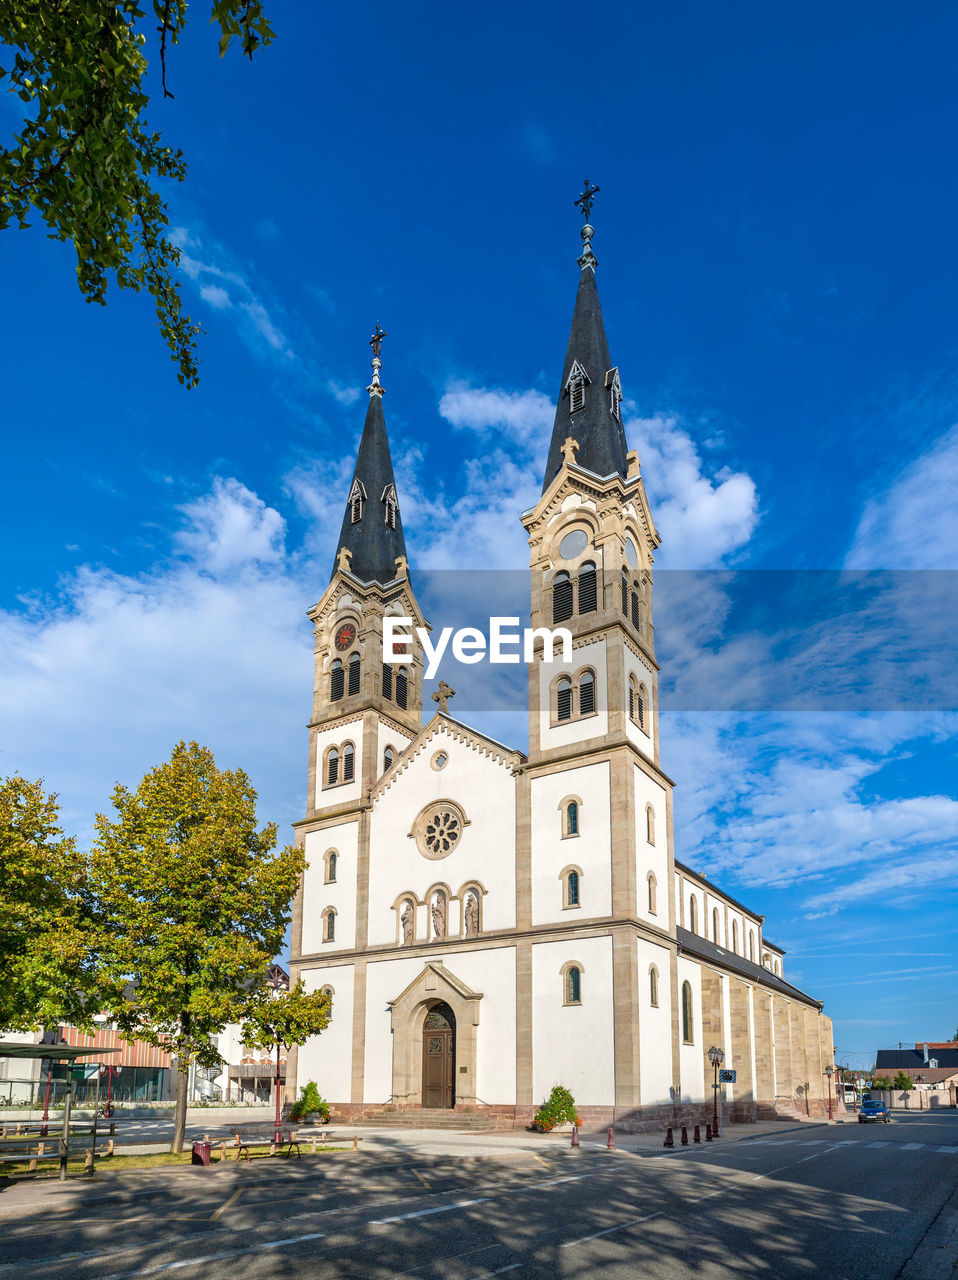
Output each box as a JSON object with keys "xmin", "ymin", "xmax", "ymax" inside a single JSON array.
[{"xmin": 90, "ymin": 742, "xmax": 304, "ymax": 1151}]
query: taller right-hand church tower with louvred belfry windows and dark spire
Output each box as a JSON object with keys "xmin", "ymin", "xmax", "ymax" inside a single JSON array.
[{"xmin": 521, "ymin": 183, "xmax": 679, "ymax": 1107}]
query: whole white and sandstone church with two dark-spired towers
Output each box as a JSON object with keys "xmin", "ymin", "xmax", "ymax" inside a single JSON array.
[{"xmin": 288, "ymin": 202, "xmax": 834, "ymax": 1128}]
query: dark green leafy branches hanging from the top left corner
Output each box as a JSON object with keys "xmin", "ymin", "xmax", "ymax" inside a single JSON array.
[{"xmin": 0, "ymin": 0, "xmax": 274, "ymax": 387}]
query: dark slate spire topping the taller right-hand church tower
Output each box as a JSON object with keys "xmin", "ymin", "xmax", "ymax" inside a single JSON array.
[{"xmin": 542, "ymin": 207, "xmax": 629, "ymax": 493}]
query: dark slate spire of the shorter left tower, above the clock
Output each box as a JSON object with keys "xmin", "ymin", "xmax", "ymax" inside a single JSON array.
[{"xmin": 333, "ymin": 335, "xmax": 406, "ymax": 584}]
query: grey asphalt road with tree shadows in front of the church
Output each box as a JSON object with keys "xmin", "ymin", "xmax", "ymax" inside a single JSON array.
[{"xmin": 0, "ymin": 1114, "xmax": 958, "ymax": 1280}]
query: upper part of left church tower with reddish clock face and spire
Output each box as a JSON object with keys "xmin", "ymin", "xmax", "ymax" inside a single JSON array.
[{"xmin": 297, "ymin": 325, "xmax": 425, "ymax": 823}]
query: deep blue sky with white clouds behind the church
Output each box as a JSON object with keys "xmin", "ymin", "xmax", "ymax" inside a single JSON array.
[{"xmin": 0, "ymin": 3, "xmax": 958, "ymax": 1061}]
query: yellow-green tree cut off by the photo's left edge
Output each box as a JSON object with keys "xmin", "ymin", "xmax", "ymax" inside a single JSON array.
[{"xmin": 0, "ymin": 776, "xmax": 97, "ymax": 1030}]
